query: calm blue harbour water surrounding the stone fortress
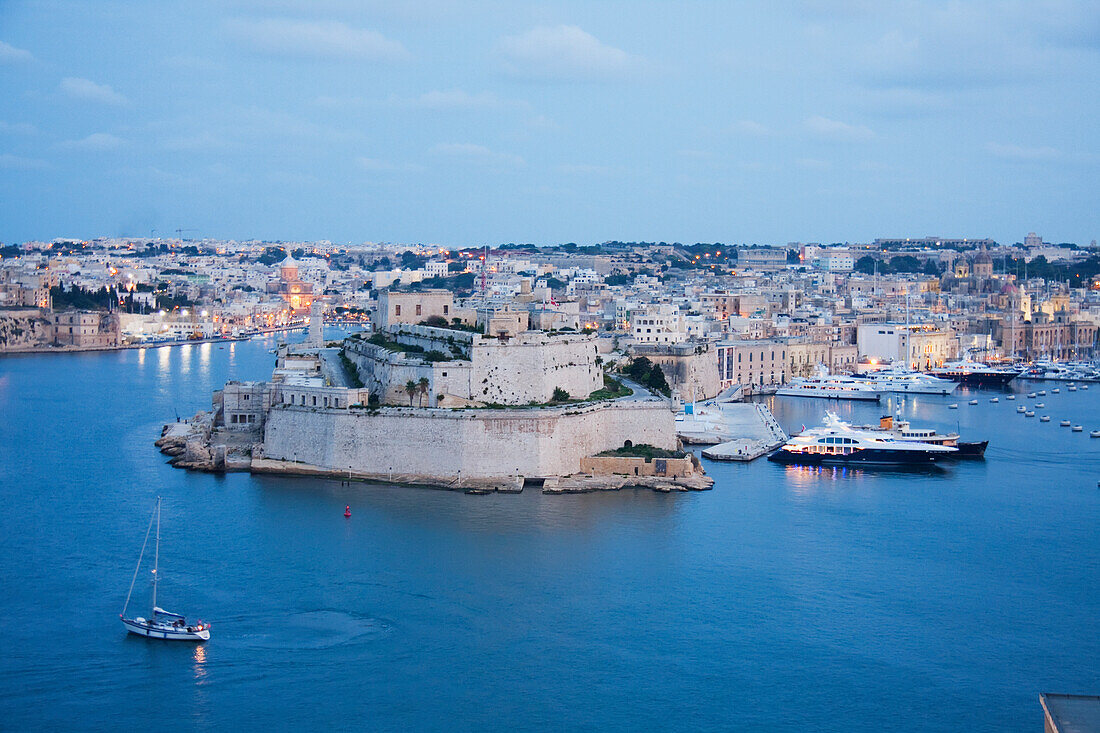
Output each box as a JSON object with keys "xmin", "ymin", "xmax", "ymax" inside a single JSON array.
[{"xmin": 0, "ymin": 340, "xmax": 1100, "ymax": 731}]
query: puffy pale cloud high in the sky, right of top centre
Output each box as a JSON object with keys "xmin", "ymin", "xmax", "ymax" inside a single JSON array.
[{"xmin": 499, "ymin": 25, "xmax": 641, "ymax": 81}]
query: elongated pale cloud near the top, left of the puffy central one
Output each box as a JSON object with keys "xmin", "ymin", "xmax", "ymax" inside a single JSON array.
[{"xmin": 227, "ymin": 18, "xmax": 409, "ymax": 62}]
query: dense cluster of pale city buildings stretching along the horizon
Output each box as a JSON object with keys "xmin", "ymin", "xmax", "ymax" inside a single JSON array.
[{"xmin": 0, "ymin": 233, "xmax": 1100, "ymax": 400}]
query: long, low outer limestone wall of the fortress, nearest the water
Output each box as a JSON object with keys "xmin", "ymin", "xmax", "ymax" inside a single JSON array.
[{"xmin": 264, "ymin": 401, "xmax": 675, "ymax": 483}]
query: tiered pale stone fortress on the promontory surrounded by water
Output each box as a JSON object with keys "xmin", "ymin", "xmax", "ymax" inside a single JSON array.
[{"xmin": 158, "ymin": 292, "xmax": 713, "ymax": 493}]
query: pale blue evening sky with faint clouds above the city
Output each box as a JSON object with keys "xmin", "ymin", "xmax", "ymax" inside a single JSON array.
[{"xmin": 0, "ymin": 0, "xmax": 1100, "ymax": 247}]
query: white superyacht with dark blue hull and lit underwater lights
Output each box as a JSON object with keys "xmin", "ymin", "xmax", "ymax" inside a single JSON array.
[{"xmin": 768, "ymin": 415, "xmax": 958, "ymax": 466}]
